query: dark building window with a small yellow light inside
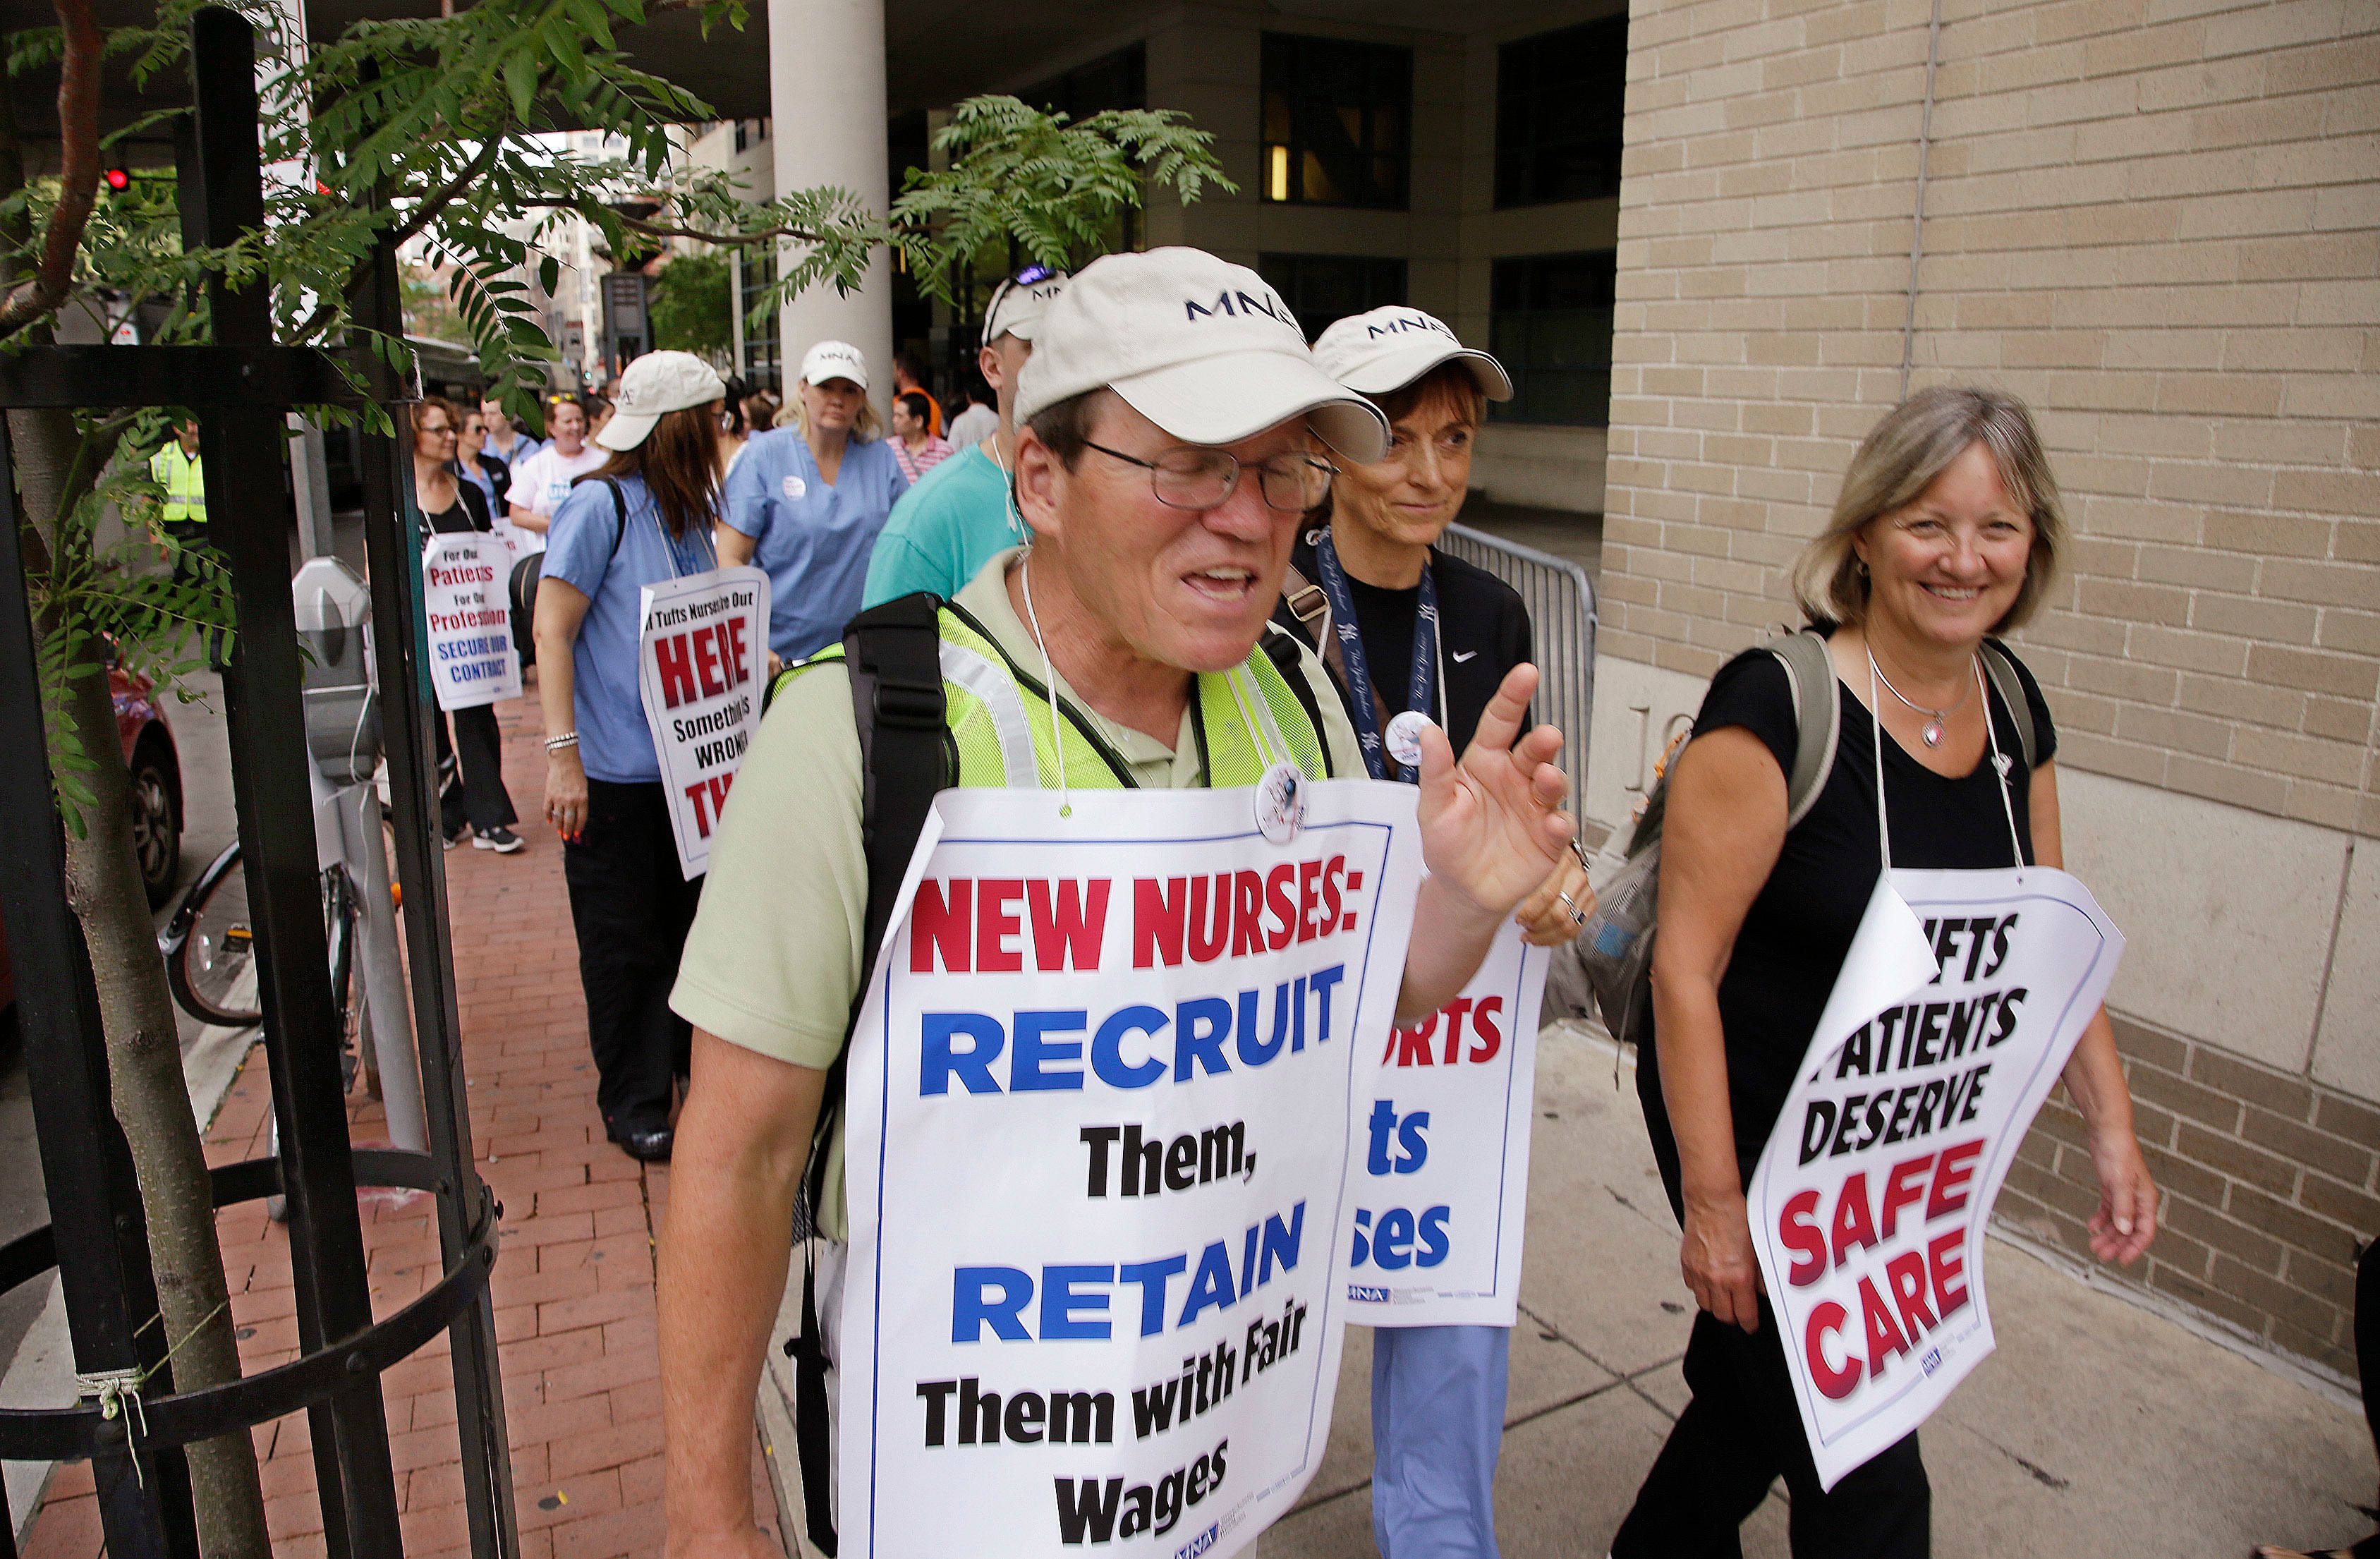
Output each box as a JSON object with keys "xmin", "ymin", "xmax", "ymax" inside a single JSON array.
[{"xmin": 1261, "ymin": 33, "xmax": 1414, "ymax": 212}]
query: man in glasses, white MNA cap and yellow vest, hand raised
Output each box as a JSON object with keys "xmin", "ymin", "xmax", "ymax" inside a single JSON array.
[{"xmin": 660, "ymin": 248, "xmax": 1571, "ymax": 1559}]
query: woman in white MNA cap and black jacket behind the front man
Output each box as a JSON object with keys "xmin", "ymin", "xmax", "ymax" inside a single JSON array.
[{"xmin": 1275, "ymin": 307, "xmax": 1595, "ymax": 1559}]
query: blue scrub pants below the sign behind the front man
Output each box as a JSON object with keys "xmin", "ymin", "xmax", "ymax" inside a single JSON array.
[{"xmin": 1371, "ymin": 1326, "xmax": 1511, "ymax": 1559}]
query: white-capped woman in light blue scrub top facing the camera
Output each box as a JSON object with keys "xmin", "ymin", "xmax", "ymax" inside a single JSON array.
[{"xmin": 719, "ymin": 340, "xmax": 909, "ymax": 664}]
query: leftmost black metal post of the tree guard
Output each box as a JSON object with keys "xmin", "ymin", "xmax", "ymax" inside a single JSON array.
[{"xmin": 0, "ymin": 421, "xmax": 198, "ymax": 1559}]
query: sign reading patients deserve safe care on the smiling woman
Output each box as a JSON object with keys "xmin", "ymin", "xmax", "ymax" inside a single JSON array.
[{"xmin": 1747, "ymin": 866, "xmax": 2123, "ymax": 1488}]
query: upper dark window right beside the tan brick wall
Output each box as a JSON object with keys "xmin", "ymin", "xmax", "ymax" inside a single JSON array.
[{"xmin": 1495, "ymin": 17, "xmax": 1628, "ymax": 207}]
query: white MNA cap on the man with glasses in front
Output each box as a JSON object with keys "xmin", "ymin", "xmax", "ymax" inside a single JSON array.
[{"xmin": 1016, "ymin": 248, "xmax": 1388, "ymax": 462}]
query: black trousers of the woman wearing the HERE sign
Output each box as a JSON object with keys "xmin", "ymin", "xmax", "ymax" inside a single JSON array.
[{"xmin": 561, "ymin": 778, "xmax": 702, "ymax": 1138}]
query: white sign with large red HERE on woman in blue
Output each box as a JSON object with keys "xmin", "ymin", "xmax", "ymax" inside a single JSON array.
[{"xmin": 636, "ymin": 569, "xmax": 769, "ymax": 880}]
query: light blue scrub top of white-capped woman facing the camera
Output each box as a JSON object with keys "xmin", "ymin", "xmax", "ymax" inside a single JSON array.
[{"xmin": 721, "ymin": 428, "xmax": 909, "ymax": 664}]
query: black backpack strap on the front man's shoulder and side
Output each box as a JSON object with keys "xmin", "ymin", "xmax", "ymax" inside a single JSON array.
[{"xmin": 785, "ymin": 590, "xmax": 959, "ymax": 1559}]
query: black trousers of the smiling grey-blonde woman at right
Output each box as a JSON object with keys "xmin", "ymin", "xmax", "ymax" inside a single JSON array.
[{"xmin": 1611, "ymin": 1299, "xmax": 1933, "ymax": 1559}]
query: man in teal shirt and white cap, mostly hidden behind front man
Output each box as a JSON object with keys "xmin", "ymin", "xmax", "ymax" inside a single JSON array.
[{"xmin": 864, "ymin": 265, "xmax": 1067, "ymax": 607}]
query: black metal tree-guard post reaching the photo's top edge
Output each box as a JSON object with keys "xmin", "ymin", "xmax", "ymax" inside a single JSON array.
[{"xmin": 190, "ymin": 7, "xmax": 402, "ymax": 1559}]
